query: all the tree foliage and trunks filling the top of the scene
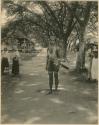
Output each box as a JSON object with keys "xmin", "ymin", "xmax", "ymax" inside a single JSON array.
[{"xmin": 2, "ymin": 0, "xmax": 98, "ymax": 71}]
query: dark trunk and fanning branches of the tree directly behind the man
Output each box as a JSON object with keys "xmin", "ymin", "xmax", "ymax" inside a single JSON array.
[{"xmin": 37, "ymin": 1, "xmax": 76, "ymax": 58}]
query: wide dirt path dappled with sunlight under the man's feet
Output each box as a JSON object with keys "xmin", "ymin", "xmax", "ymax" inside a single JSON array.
[{"xmin": 2, "ymin": 49, "xmax": 98, "ymax": 124}]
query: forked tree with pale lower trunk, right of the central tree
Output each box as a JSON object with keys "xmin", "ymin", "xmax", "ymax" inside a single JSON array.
[{"xmin": 65, "ymin": 2, "xmax": 92, "ymax": 71}]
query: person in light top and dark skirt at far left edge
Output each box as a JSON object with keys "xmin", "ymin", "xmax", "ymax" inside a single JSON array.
[{"xmin": 1, "ymin": 48, "xmax": 9, "ymax": 74}]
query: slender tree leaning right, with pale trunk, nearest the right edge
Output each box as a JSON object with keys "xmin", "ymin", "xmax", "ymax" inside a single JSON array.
[{"xmin": 76, "ymin": 2, "xmax": 96, "ymax": 71}]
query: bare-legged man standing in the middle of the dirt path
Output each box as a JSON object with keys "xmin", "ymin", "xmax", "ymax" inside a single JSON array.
[{"xmin": 46, "ymin": 36, "xmax": 60, "ymax": 94}]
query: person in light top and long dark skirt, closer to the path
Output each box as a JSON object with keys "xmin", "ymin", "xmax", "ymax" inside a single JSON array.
[{"xmin": 12, "ymin": 50, "xmax": 20, "ymax": 75}]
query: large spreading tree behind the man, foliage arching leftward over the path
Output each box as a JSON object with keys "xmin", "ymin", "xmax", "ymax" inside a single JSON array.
[{"xmin": 1, "ymin": 1, "xmax": 76, "ymax": 58}]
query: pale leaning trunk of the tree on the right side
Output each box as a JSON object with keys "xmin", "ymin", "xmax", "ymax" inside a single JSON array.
[{"xmin": 76, "ymin": 2, "xmax": 92, "ymax": 71}]
